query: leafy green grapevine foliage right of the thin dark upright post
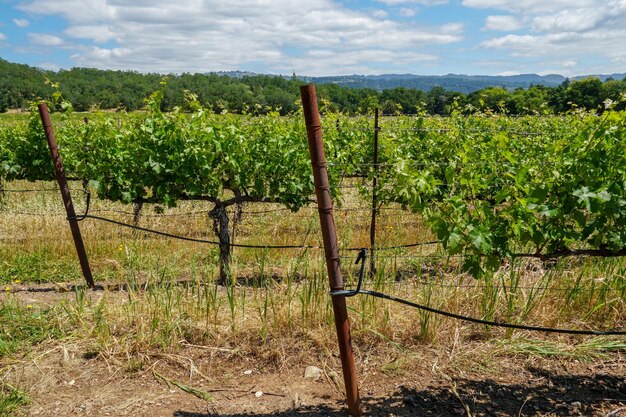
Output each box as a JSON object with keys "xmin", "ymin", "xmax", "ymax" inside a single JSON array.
[{"xmin": 368, "ymin": 111, "xmax": 626, "ymax": 275}]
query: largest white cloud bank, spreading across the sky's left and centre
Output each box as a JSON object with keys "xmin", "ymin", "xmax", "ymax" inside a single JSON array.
[{"xmin": 15, "ymin": 0, "xmax": 463, "ymax": 75}]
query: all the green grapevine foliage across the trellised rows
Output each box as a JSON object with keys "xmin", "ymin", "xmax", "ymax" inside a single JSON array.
[{"xmin": 0, "ymin": 94, "xmax": 626, "ymax": 276}]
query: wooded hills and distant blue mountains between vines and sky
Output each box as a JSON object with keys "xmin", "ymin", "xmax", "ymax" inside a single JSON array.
[{"xmin": 0, "ymin": 58, "xmax": 626, "ymax": 114}]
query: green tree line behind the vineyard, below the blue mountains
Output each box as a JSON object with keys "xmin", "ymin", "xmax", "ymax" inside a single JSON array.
[{"xmin": 0, "ymin": 59, "xmax": 626, "ymax": 115}]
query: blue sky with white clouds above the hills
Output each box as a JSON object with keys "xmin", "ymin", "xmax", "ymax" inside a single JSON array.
[{"xmin": 0, "ymin": 0, "xmax": 626, "ymax": 76}]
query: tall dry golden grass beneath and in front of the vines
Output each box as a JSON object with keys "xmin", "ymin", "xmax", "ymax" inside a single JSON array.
[{"xmin": 0, "ymin": 178, "xmax": 626, "ymax": 394}]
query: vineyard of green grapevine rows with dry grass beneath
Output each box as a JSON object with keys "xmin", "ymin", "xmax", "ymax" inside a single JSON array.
[{"xmin": 0, "ymin": 92, "xmax": 626, "ymax": 416}]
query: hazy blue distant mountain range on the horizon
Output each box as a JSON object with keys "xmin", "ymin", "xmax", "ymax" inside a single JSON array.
[{"xmin": 299, "ymin": 73, "xmax": 626, "ymax": 94}]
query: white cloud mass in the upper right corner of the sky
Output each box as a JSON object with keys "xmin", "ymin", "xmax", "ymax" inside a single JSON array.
[{"xmin": 463, "ymin": 0, "xmax": 626, "ymax": 72}]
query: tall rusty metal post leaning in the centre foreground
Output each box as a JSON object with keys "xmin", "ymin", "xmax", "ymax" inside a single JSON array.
[{"xmin": 300, "ymin": 85, "xmax": 362, "ymax": 417}]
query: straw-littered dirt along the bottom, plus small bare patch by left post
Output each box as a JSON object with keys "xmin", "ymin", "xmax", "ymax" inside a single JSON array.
[{"xmin": 2, "ymin": 286, "xmax": 626, "ymax": 417}]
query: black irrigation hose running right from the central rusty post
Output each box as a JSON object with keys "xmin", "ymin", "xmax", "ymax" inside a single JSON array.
[{"xmin": 330, "ymin": 249, "xmax": 626, "ymax": 336}]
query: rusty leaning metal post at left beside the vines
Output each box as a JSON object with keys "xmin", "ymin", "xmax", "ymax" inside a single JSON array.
[{"xmin": 39, "ymin": 103, "xmax": 94, "ymax": 288}]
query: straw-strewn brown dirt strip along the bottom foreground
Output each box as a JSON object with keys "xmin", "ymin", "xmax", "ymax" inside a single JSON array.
[{"xmin": 12, "ymin": 347, "xmax": 626, "ymax": 417}]
